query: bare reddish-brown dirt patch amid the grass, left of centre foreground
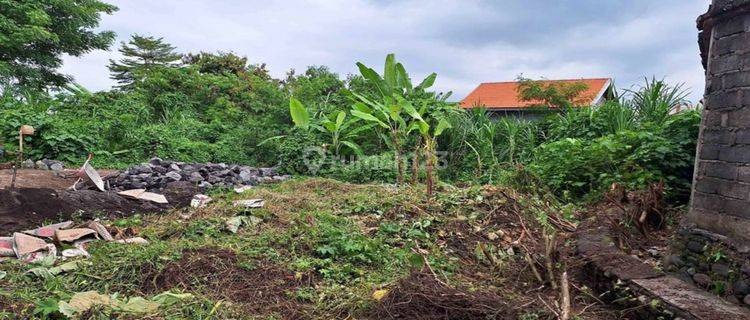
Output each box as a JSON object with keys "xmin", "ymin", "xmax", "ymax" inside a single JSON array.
[{"xmin": 141, "ymin": 248, "xmax": 309, "ymax": 319}]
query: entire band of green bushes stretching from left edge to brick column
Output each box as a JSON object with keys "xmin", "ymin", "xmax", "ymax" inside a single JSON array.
[{"xmin": 0, "ymin": 45, "xmax": 700, "ymax": 205}]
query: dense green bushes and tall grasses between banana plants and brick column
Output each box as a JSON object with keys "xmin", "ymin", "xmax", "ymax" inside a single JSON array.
[{"xmin": 441, "ymin": 80, "xmax": 700, "ymax": 202}]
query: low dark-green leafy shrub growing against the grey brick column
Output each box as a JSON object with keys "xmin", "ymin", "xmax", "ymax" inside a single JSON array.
[{"xmin": 527, "ymin": 127, "xmax": 694, "ymax": 200}]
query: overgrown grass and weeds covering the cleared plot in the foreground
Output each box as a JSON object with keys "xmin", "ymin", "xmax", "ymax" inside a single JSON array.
[{"xmin": 0, "ymin": 179, "xmax": 600, "ymax": 319}]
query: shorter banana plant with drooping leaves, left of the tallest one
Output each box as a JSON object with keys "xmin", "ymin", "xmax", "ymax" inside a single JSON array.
[{"xmin": 289, "ymin": 97, "xmax": 373, "ymax": 156}]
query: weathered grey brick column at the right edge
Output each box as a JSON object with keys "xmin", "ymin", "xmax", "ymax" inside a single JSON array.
[{"xmin": 686, "ymin": 0, "xmax": 750, "ymax": 245}]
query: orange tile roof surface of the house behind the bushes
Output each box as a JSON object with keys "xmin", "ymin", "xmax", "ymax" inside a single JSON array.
[{"xmin": 461, "ymin": 78, "xmax": 611, "ymax": 109}]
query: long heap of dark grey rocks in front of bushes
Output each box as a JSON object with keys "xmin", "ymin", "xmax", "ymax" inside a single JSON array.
[{"xmin": 105, "ymin": 158, "xmax": 291, "ymax": 191}]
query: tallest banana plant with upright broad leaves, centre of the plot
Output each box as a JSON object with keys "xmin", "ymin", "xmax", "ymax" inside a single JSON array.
[{"xmin": 350, "ymin": 54, "xmax": 437, "ymax": 184}]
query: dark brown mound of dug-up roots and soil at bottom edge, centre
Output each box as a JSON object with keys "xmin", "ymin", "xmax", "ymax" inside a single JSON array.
[{"xmin": 370, "ymin": 272, "xmax": 516, "ymax": 320}]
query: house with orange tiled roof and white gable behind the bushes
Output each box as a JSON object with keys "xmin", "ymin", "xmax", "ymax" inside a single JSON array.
[{"xmin": 459, "ymin": 78, "xmax": 614, "ymax": 118}]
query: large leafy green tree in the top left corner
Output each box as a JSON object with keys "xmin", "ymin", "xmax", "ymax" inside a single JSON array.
[{"xmin": 0, "ymin": 0, "xmax": 117, "ymax": 90}]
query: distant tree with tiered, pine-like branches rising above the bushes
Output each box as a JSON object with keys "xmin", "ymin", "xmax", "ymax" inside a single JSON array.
[{"xmin": 109, "ymin": 34, "xmax": 182, "ymax": 90}]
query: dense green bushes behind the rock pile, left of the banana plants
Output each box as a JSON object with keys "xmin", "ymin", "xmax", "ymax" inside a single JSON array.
[{"xmin": 0, "ymin": 61, "xmax": 374, "ymax": 172}]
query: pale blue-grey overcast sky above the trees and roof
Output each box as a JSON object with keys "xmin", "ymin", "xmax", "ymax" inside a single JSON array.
[{"xmin": 63, "ymin": 0, "xmax": 709, "ymax": 101}]
